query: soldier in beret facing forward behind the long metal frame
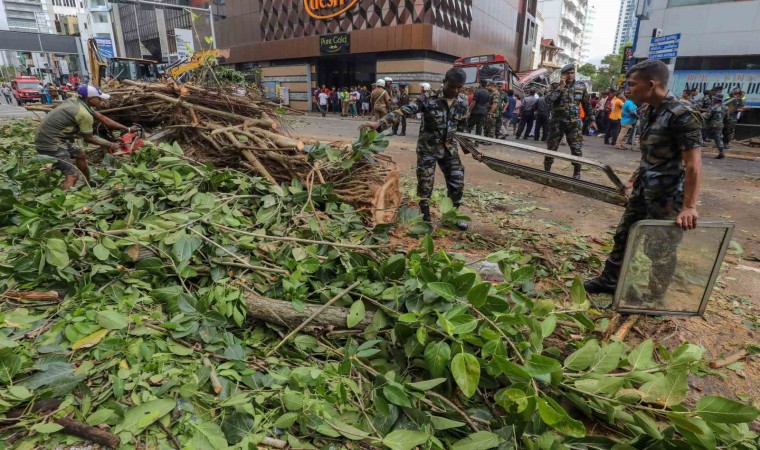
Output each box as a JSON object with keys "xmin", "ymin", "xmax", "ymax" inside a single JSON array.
[{"xmin": 544, "ymin": 64, "xmax": 597, "ymax": 179}]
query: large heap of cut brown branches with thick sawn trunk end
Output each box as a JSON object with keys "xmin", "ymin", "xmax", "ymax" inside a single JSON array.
[{"xmin": 27, "ymin": 80, "xmax": 401, "ymax": 224}]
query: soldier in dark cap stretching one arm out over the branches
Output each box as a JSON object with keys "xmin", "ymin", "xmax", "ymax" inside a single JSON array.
[{"xmin": 360, "ymin": 68, "xmax": 469, "ymax": 230}]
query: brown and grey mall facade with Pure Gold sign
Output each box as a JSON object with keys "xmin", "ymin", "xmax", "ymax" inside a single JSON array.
[{"xmin": 216, "ymin": 0, "xmax": 536, "ymax": 109}]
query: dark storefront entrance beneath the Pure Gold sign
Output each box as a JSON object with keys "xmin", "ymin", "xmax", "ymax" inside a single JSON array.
[{"xmin": 317, "ymin": 55, "xmax": 377, "ymax": 89}]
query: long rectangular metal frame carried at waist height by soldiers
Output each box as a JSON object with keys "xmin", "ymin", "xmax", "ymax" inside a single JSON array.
[{"xmin": 455, "ymin": 133, "xmax": 628, "ymax": 206}]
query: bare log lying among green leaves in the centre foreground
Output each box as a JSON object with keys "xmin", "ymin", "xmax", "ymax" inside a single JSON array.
[{"xmin": 243, "ymin": 294, "xmax": 374, "ymax": 334}]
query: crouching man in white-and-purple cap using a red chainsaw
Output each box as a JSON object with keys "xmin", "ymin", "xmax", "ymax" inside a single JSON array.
[{"xmin": 34, "ymin": 85, "xmax": 137, "ymax": 190}]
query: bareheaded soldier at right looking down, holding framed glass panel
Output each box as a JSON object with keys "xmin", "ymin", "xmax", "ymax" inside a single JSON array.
[{"xmin": 583, "ymin": 60, "xmax": 702, "ymax": 303}]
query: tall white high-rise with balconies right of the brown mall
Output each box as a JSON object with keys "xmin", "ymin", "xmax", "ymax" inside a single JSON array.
[{"xmin": 538, "ymin": 0, "xmax": 593, "ymax": 66}]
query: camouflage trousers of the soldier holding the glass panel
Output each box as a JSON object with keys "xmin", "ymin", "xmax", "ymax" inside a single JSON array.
[{"xmin": 608, "ymin": 187, "xmax": 683, "ymax": 296}]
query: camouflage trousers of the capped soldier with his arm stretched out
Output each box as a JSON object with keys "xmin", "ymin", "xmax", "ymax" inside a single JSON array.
[{"xmin": 417, "ymin": 150, "xmax": 464, "ymax": 206}]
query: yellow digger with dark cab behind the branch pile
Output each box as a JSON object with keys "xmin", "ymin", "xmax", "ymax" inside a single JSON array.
[{"xmin": 88, "ymin": 39, "xmax": 158, "ymax": 87}]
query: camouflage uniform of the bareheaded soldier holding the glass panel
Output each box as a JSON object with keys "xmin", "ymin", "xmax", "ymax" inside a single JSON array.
[{"xmin": 586, "ymin": 93, "xmax": 702, "ymax": 297}]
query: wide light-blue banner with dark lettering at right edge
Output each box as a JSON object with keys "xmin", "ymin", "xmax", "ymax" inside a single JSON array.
[{"xmin": 670, "ymin": 70, "xmax": 760, "ymax": 108}]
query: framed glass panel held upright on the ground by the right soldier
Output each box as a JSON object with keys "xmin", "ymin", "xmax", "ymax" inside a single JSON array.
[{"xmin": 615, "ymin": 221, "xmax": 733, "ymax": 314}]
